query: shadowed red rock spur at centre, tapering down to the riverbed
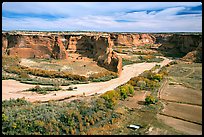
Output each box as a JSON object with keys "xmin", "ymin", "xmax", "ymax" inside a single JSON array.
[{"xmin": 65, "ymin": 35, "xmax": 122, "ymax": 74}]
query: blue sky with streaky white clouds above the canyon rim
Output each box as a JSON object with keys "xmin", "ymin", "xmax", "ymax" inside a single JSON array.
[{"xmin": 2, "ymin": 2, "xmax": 202, "ymax": 32}]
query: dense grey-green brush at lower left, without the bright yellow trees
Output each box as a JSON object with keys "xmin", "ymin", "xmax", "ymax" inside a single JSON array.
[{"xmin": 2, "ymin": 98, "xmax": 118, "ymax": 135}]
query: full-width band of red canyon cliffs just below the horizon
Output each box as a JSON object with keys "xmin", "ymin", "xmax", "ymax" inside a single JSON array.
[{"xmin": 2, "ymin": 33, "xmax": 202, "ymax": 74}]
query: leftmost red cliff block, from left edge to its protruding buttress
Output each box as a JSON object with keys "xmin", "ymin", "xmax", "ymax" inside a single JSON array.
[{"xmin": 2, "ymin": 34, "xmax": 67, "ymax": 59}]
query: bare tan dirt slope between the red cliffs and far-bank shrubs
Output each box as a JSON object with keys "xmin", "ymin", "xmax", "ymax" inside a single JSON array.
[{"xmin": 20, "ymin": 53, "xmax": 107, "ymax": 76}]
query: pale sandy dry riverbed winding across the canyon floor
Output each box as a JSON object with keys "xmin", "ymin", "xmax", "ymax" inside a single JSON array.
[{"xmin": 2, "ymin": 58, "xmax": 172, "ymax": 102}]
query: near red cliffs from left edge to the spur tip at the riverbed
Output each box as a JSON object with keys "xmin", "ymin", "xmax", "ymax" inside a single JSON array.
[{"xmin": 2, "ymin": 34, "xmax": 122, "ymax": 74}]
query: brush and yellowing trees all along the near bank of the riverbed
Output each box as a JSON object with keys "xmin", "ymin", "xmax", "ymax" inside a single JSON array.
[{"xmin": 2, "ymin": 60, "xmax": 175, "ymax": 135}]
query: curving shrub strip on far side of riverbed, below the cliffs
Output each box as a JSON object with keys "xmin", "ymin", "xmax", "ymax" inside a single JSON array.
[{"xmin": 2, "ymin": 56, "xmax": 118, "ymax": 86}]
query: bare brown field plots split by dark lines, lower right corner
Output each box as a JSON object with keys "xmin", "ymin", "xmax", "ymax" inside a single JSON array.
[{"xmin": 157, "ymin": 78, "xmax": 202, "ymax": 135}]
